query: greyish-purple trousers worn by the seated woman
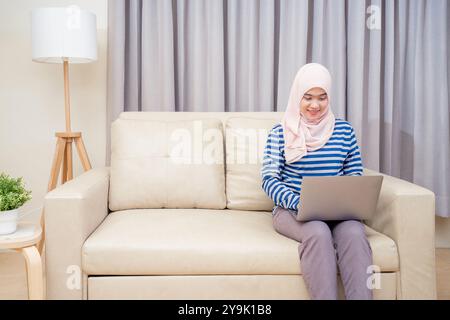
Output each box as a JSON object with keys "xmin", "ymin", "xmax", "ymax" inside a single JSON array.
[{"xmin": 273, "ymin": 207, "xmax": 372, "ymax": 300}]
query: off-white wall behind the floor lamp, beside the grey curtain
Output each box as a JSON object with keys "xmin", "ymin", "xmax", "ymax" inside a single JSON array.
[{"xmin": 0, "ymin": 0, "xmax": 107, "ymax": 225}]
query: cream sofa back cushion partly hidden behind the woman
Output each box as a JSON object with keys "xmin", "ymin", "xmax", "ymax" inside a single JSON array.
[{"xmin": 225, "ymin": 117, "xmax": 279, "ymax": 211}]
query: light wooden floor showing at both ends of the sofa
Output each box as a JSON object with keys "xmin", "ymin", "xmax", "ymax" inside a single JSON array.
[{"xmin": 0, "ymin": 249, "xmax": 450, "ymax": 300}]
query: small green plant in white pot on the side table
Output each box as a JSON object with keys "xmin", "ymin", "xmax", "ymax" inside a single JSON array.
[{"xmin": 0, "ymin": 173, "xmax": 31, "ymax": 235}]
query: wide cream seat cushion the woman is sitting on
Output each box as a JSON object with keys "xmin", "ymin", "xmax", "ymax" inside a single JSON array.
[{"xmin": 82, "ymin": 209, "xmax": 398, "ymax": 275}]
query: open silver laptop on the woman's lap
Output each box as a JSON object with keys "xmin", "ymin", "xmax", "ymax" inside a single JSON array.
[{"xmin": 297, "ymin": 176, "xmax": 383, "ymax": 221}]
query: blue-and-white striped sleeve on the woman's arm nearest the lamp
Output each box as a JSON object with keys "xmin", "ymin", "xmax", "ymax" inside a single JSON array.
[{"xmin": 261, "ymin": 125, "xmax": 300, "ymax": 210}]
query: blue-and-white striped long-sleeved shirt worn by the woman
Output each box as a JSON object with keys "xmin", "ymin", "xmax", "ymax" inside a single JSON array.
[{"xmin": 261, "ymin": 119, "xmax": 363, "ymax": 214}]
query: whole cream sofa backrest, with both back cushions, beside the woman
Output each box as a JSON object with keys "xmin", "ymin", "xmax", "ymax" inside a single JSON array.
[{"xmin": 109, "ymin": 112, "xmax": 283, "ymax": 211}]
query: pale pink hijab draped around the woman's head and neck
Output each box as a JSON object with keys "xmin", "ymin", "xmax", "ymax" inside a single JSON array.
[{"xmin": 281, "ymin": 63, "xmax": 335, "ymax": 163}]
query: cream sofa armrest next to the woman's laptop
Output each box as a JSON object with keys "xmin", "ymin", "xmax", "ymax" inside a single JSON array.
[{"xmin": 364, "ymin": 169, "xmax": 437, "ymax": 299}]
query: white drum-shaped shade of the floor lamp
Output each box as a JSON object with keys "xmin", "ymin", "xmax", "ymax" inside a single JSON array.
[{"xmin": 31, "ymin": 6, "xmax": 97, "ymax": 63}]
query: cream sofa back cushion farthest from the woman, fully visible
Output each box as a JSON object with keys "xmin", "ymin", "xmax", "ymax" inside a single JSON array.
[{"xmin": 109, "ymin": 119, "xmax": 226, "ymax": 211}]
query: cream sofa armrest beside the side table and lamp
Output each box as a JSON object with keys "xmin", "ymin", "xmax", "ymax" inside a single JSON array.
[{"xmin": 44, "ymin": 168, "xmax": 109, "ymax": 299}]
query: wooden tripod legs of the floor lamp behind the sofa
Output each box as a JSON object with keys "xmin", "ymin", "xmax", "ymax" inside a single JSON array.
[{"xmin": 47, "ymin": 132, "xmax": 92, "ymax": 191}]
